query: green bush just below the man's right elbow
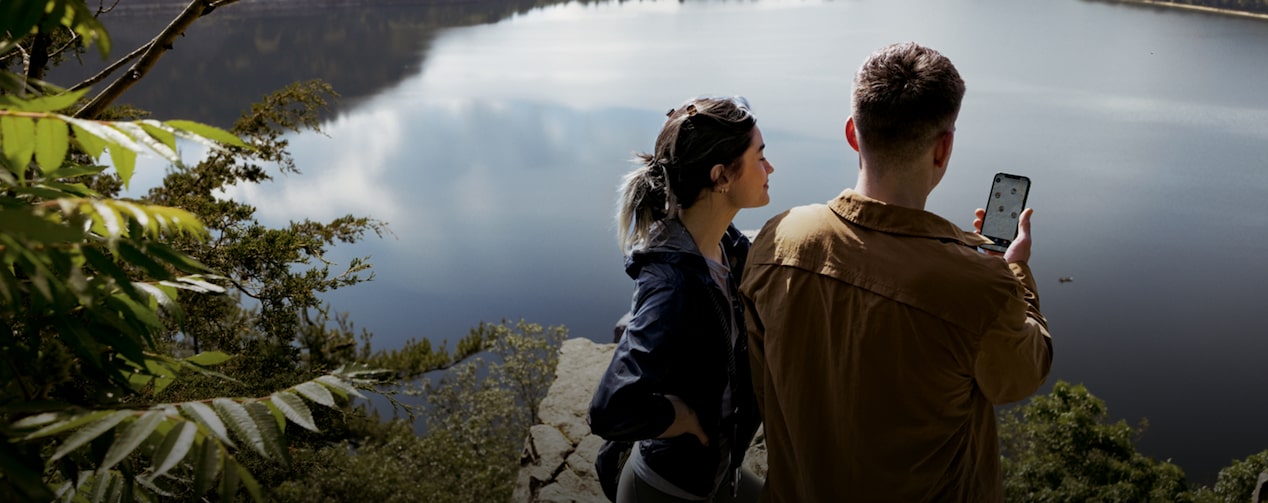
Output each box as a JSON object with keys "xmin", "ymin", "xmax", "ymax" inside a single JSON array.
[{"xmin": 999, "ymin": 381, "xmax": 1192, "ymax": 502}]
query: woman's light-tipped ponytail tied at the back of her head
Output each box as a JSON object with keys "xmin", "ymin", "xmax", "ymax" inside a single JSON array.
[{"xmin": 616, "ymin": 153, "xmax": 673, "ymax": 253}]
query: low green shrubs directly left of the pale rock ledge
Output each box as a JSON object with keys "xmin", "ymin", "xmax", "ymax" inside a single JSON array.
[{"xmin": 273, "ymin": 321, "xmax": 567, "ymax": 503}]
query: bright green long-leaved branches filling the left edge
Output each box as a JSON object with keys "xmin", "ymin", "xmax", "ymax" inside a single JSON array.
[{"xmin": 0, "ymin": 0, "xmax": 380, "ymax": 500}]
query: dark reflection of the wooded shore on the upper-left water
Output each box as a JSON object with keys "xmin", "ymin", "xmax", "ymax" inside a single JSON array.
[{"xmin": 51, "ymin": 0, "xmax": 611, "ymax": 128}]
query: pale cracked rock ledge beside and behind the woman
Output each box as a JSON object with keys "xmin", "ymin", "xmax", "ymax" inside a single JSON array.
[{"xmin": 511, "ymin": 332, "xmax": 766, "ymax": 503}]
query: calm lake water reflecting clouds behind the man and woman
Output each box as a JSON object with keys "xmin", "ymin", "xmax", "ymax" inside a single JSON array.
[{"xmin": 61, "ymin": 0, "xmax": 1268, "ymax": 483}]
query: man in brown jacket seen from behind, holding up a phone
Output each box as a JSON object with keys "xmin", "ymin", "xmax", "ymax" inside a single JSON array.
[{"xmin": 741, "ymin": 43, "xmax": 1052, "ymax": 502}]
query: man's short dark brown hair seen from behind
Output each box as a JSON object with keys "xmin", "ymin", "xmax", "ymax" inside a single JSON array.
[{"xmin": 853, "ymin": 42, "xmax": 964, "ymax": 160}]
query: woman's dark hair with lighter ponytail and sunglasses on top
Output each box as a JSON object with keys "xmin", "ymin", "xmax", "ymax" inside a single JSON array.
[{"xmin": 616, "ymin": 98, "xmax": 757, "ymax": 251}]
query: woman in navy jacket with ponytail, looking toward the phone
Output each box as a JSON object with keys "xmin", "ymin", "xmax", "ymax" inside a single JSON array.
[{"xmin": 590, "ymin": 99, "xmax": 775, "ymax": 503}]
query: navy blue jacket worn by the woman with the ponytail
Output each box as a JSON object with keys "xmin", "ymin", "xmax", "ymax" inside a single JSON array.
[{"xmin": 590, "ymin": 219, "xmax": 760, "ymax": 497}]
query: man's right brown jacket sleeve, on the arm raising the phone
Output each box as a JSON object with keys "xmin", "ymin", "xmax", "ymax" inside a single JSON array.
[{"xmin": 974, "ymin": 262, "xmax": 1052, "ymax": 405}]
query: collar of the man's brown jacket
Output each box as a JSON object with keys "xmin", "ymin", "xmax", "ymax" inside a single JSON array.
[{"xmin": 828, "ymin": 189, "xmax": 992, "ymax": 247}]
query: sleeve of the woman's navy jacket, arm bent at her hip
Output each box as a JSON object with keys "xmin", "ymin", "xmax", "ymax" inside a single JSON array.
[{"xmin": 590, "ymin": 266, "xmax": 685, "ymax": 441}]
